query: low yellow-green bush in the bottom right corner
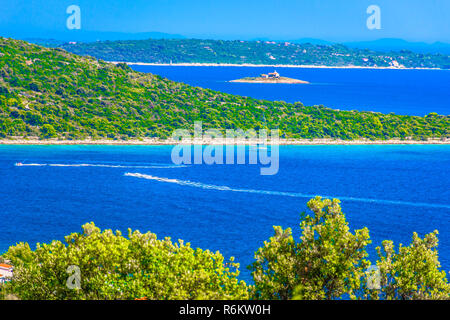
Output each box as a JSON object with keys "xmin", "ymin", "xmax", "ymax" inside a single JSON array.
[{"xmin": 370, "ymin": 231, "xmax": 450, "ymax": 300}]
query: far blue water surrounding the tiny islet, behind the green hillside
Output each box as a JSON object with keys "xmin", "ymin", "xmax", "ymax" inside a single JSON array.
[{"xmin": 131, "ymin": 65, "xmax": 450, "ymax": 116}]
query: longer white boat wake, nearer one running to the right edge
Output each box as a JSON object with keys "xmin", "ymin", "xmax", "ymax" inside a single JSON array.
[{"xmin": 125, "ymin": 172, "xmax": 450, "ymax": 209}]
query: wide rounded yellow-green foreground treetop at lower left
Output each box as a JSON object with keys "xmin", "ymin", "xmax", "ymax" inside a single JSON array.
[{"xmin": 5, "ymin": 223, "xmax": 248, "ymax": 300}]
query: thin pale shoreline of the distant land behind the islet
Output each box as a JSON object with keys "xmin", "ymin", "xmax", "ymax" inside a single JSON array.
[{"xmin": 107, "ymin": 61, "xmax": 446, "ymax": 70}]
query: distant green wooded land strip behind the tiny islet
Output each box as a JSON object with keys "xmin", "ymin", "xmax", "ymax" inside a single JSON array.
[{"xmin": 61, "ymin": 39, "xmax": 450, "ymax": 69}]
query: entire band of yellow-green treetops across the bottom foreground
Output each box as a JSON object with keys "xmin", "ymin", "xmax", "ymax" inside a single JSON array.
[{"xmin": 0, "ymin": 197, "xmax": 450, "ymax": 300}]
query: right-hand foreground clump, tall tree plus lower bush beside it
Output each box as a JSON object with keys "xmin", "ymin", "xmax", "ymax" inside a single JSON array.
[{"xmin": 250, "ymin": 197, "xmax": 450, "ymax": 300}]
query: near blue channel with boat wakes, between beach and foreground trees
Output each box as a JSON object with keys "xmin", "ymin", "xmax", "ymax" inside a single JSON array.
[{"xmin": 0, "ymin": 145, "xmax": 450, "ymax": 280}]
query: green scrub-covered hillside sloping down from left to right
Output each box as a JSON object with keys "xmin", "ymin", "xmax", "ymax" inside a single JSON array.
[{"xmin": 0, "ymin": 38, "xmax": 450, "ymax": 139}]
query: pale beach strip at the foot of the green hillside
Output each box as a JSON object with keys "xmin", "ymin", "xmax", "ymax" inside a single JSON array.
[{"xmin": 0, "ymin": 138, "xmax": 450, "ymax": 146}]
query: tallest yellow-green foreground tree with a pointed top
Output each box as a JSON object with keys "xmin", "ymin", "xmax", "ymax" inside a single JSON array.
[{"xmin": 251, "ymin": 197, "xmax": 370, "ymax": 299}]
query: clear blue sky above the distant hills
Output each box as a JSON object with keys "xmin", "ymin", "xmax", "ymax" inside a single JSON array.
[{"xmin": 0, "ymin": 0, "xmax": 450, "ymax": 42}]
